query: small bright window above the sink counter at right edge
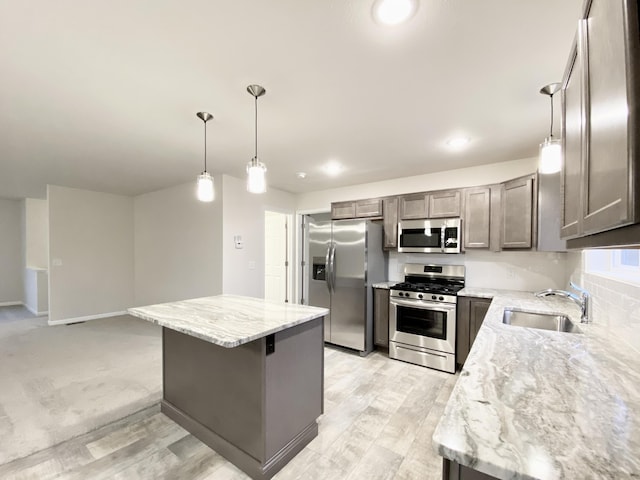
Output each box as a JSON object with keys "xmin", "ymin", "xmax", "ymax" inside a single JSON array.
[{"xmin": 584, "ymin": 249, "xmax": 640, "ymax": 285}]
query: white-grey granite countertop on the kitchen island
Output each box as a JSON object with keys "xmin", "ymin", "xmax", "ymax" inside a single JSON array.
[{"xmin": 128, "ymin": 295, "xmax": 329, "ymax": 348}]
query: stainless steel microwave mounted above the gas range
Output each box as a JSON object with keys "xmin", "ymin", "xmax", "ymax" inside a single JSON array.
[{"xmin": 398, "ymin": 218, "xmax": 462, "ymax": 253}]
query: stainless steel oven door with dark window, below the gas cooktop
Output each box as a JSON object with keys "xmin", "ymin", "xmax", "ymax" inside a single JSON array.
[{"xmin": 389, "ymin": 298, "xmax": 456, "ymax": 354}]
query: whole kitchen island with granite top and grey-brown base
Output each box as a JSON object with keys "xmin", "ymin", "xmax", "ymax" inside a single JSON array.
[{"xmin": 128, "ymin": 295, "xmax": 329, "ymax": 479}]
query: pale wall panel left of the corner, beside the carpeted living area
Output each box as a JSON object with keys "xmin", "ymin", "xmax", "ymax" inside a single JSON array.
[{"xmin": 47, "ymin": 185, "xmax": 134, "ymax": 323}]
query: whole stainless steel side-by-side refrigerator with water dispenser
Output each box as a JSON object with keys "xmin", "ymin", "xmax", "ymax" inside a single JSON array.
[{"xmin": 305, "ymin": 215, "xmax": 387, "ymax": 355}]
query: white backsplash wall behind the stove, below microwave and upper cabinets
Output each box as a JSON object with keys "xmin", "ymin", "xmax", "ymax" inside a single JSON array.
[{"xmin": 389, "ymin": 250, "xmax": 567, "ymax": 291}]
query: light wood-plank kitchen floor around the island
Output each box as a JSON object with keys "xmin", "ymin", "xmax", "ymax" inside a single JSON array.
[{"xmin": 0, "ymin": 348, "xmax": 457, "ymax": 480}]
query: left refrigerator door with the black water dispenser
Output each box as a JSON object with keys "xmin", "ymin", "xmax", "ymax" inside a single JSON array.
[{"xmin": 306, "ymin": 215, "xmax": 331, "ymax": 342}]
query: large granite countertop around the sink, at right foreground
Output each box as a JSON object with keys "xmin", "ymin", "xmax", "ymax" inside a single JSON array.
[{"xmin": 433, "ymin": 288, "xmax": 640, "ymax": 479}]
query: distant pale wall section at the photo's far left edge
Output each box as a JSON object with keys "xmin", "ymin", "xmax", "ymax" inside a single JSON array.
[{"xmin": 0, "ymin": 198, "xmax": 24, "ymax": 305}]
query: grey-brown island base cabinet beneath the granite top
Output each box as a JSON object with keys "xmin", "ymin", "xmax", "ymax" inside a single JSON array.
[{"xmin": 161, "ymin": 318, "xmax": 324, "ymax": 479}]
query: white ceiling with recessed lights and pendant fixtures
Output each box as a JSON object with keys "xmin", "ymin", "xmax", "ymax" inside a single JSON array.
[{"xmin": 0, "ymin": 0, "xmax": 582, "ymax": 197}]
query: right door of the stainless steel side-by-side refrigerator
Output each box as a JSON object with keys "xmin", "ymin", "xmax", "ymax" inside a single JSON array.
[{"xmin": 329, "ymin": 220, "xmax": 367, "ymax": 351}]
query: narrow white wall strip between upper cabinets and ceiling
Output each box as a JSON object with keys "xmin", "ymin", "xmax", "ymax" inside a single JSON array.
[{"xmin": 296, "ymin": 158, "xmax": 538, "ymax": 213}]
